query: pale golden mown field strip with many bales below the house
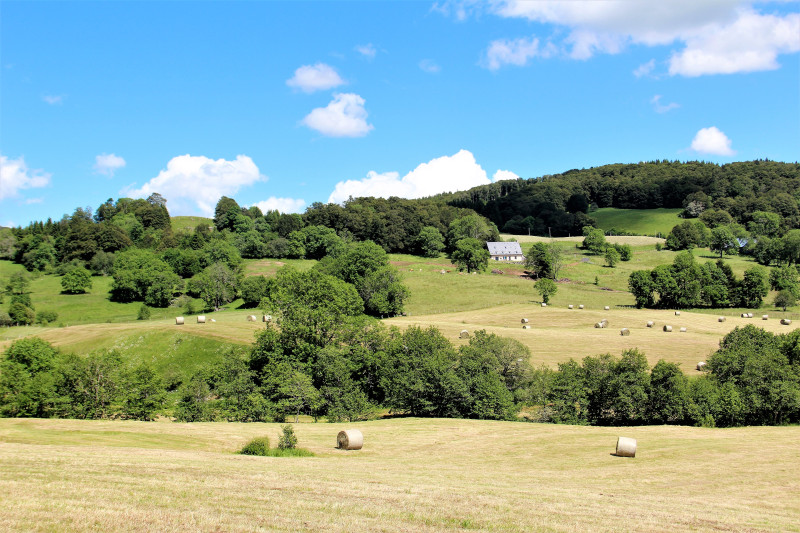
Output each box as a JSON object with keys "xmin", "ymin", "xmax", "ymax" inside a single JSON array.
[{"xmin": 385, "ymin": 299, "xmax": 796, "ymax": 374}]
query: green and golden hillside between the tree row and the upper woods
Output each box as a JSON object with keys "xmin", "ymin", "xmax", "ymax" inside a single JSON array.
[{"xmin": 0, "ymin": 237, "xmax": 800, "ymax": 376}]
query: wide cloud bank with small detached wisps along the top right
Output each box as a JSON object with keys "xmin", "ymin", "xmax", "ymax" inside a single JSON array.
[{"xmin": 456, "ymin": 0, "xmax": 800, "ymax": 76}]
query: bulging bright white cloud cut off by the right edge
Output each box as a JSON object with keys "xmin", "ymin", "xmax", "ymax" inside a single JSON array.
[{"xmin": 669, "ymin": 12, "xmax": 800, "ymax": 76}]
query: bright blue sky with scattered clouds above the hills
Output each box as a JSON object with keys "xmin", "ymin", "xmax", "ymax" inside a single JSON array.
[{"xmin": 0, "ymin": 0, "xmax": 800, "ymax": 225}]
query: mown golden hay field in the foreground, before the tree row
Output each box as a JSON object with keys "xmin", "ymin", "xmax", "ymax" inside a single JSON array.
[{"xmin": 0, "ymin": 419, "xmax": 800, "ymax": 531}]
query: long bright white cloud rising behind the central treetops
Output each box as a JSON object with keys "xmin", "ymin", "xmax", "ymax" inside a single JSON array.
[{"xmin": 328, "ymin": 150, "xmax": 490, "ymax": 203}]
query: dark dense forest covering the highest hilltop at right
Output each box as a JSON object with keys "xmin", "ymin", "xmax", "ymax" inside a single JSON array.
[{"xmin": 436, "ymin": 160, "xmax": 800, "ymax": 237}]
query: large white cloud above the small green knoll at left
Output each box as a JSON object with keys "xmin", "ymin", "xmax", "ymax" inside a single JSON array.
[{"xmin": 124, "ymin": 154, "xmax": 267, "ymax": 216}]
